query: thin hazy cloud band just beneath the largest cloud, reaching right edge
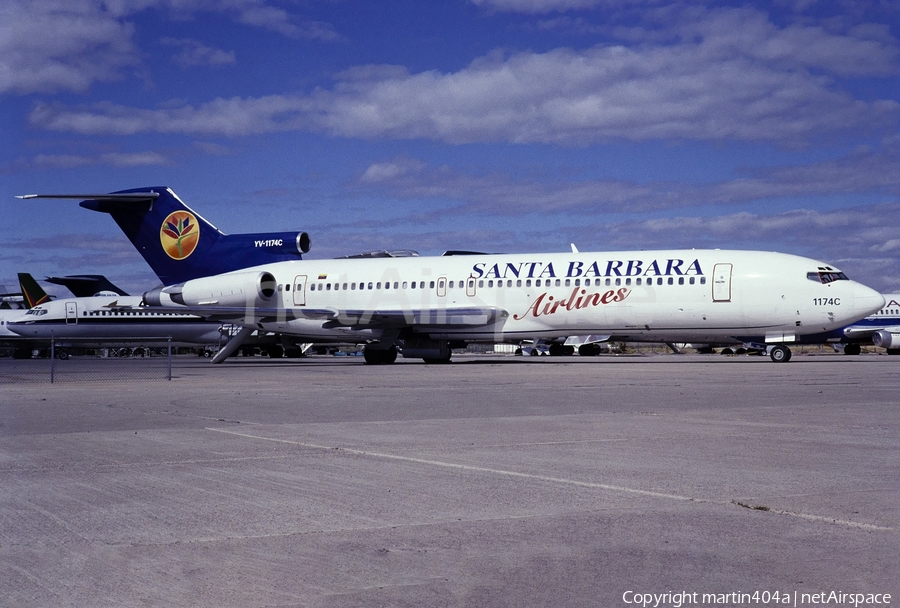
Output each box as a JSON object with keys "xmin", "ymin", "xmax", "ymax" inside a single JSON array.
[{"xmin": 350, "ymin": 140, "xmax": 900, "ymax": 216}]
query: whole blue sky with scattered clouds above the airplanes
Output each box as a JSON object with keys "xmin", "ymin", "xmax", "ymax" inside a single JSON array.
[{"xmin": 0, "ymin": 0, "xmax": 900, "ymax": 295}]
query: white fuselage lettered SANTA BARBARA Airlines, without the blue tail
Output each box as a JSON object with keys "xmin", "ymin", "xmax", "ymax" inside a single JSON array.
[{"xmin": 155, "ymin": 250, "xmax": 884, "ymax": 343}]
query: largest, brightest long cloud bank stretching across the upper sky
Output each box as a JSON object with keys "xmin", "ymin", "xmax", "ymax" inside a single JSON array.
[{"xmin": 24, "ymin": 9, "xmax": 900, "ymax": 145}]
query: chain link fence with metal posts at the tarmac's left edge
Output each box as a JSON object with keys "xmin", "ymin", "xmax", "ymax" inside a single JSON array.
[{"xmin": 0, "ymin": 338, "xmax": 173, "ymax": 384}]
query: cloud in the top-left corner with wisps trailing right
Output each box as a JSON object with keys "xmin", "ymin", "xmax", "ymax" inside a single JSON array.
[{"xmin": 0, "ymin": 0, "xmax": 340, "ymax": 94}]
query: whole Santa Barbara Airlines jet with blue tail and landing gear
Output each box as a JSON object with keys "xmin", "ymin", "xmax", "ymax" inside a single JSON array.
[{"xmin": 22, "ymin": 188, "xmax": 884, "ymax": 363}]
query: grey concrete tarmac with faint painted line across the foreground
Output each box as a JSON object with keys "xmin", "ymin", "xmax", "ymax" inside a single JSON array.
[{"xmin": 0, "ymin": 354, "xmax": 900, "ymax": 608}]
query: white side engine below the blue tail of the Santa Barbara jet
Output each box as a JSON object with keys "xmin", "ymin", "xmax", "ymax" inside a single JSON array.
[{"xmin": 144, "ymin": 270, "xmax": 278, "ymax": 307}]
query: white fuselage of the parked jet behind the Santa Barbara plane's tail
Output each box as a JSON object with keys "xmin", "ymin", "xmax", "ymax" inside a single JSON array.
[{"xmin": 6, "ymin": 295, "xmax": 222, "ymax": 344}]
